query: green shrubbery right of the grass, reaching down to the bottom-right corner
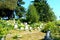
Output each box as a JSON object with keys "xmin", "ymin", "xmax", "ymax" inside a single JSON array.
[{"xmin": 42, "ymin": 22, "xmax": 60, "ymax": 40}]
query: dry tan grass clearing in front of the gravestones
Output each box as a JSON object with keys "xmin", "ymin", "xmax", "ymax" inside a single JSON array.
[{"xmin": 5, "ymin": 30, "xmax": 45, "ymax": 40}]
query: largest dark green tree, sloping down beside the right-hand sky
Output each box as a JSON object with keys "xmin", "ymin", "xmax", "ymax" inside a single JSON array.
[{"xmin": 33, "ymin": 0, "xmax": 56, "ymax": 22}]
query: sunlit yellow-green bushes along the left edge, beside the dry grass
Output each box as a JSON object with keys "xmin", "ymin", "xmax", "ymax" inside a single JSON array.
[{"xmin": 0, "ymin": 20, "xmax": 13, "ymax": 38}]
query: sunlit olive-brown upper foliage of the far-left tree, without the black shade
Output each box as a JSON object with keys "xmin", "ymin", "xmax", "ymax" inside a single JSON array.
[{"xmin": 0, "ymin": 0, "xmax": 18, "ymax": 10}]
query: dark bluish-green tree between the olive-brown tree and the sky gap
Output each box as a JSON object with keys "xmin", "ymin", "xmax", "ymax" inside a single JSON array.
[{"xmin": 16, "ymin": 0, "xmax": 25, "ymax": 17}]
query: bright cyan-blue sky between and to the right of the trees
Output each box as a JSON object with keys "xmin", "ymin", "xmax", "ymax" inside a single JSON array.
[{"xmin": 23, "ymin": 0, "xmax": 60, "ymax": 20}]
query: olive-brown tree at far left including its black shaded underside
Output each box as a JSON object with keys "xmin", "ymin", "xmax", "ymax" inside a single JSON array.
[{"xmin": 0, "ymin": 0, "xmax": 18, "ymax": 18}]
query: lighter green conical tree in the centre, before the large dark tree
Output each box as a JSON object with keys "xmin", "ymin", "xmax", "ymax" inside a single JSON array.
[{"xmin": 27, "ymin": 5, "xmax": 39, "ymax": 23}]
